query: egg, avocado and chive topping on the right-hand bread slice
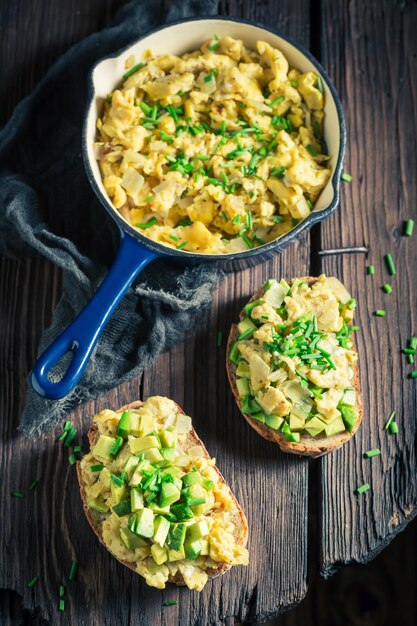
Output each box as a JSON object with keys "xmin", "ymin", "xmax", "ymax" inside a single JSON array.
[{"xmin": 229, "ymin": 275, "xmax": 359, "ymax": 443}]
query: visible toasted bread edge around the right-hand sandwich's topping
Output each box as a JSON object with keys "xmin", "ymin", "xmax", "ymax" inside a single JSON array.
[{"xmin": 226, "ymin": 276, "xmax": 363, "ymax": 458}]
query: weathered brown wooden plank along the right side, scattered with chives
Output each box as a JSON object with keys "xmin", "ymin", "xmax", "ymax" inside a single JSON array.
[{"xmin": 321, "ymin": 0, "xmax": 417, "ymax": 576}]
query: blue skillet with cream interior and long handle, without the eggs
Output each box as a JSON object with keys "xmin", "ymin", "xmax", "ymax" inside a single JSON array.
[{"xmin": 30, "ymin": 17, "xmax": 346, "ymax": 399}]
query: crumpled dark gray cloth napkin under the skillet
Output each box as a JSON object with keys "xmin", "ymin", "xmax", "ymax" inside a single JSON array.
[{"xmin": 0, "ymin": 0, "xmax": 221, "ymax": 436}]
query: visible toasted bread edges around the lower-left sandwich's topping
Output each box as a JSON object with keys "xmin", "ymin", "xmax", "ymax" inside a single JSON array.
[{"xmin": 77, "ymin": 400, "xmax": 248, "ymax": 586}]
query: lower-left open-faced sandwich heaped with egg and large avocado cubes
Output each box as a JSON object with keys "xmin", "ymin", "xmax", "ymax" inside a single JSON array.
[{"xmin": 77, "ymin": 396, "xmax": 248, "ymax": 591}]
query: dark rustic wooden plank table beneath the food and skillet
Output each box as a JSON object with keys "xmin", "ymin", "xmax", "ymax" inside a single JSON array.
[{"xmin": 0, "ymin": 0, "xmax": 417, "ymax": 626}]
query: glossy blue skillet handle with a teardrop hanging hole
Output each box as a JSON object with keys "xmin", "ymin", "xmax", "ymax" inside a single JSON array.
[{"xmin": 30, "ymin": 232, "xmax": 157, "ymax": 400}]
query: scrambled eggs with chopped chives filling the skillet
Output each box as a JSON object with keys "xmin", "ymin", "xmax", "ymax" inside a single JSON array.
[{"xmin": 95, "ymin": 36, "xmax": 331, "ymax": 254}]
